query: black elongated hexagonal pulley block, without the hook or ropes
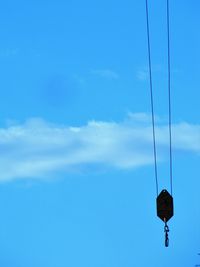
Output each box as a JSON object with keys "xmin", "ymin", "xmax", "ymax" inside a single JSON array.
[{"xmin": 156, "ymin": 189, "xmax": 174, "ymax": 223}]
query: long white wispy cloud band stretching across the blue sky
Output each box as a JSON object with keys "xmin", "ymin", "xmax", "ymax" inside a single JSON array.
[{"xmin": 0, "ymin": 113, "xmax": 200, "ymax": 181}]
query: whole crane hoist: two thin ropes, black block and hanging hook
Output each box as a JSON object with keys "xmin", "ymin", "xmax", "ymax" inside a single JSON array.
[{"xmin": 146, "ymin": 0, "xmax": 174, "ymax": 247}]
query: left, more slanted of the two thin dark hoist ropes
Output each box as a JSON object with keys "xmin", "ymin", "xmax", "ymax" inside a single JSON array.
[{"xmin": 146, "ymin": 0, "xmax": 158, "ymax": 196}]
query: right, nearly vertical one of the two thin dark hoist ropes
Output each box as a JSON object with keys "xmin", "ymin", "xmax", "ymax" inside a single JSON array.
[{"xmin": 167, "ymin": 0, "xmax": 173, "ymax": 195}]
